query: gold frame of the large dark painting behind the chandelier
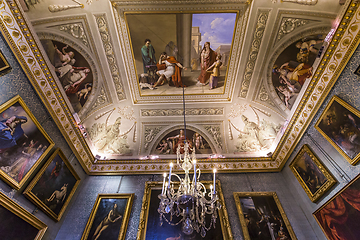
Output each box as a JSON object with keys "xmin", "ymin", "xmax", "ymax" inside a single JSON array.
[{"xmin": 136, "ymin": 180, "xmax": 233, "ymax": 240}]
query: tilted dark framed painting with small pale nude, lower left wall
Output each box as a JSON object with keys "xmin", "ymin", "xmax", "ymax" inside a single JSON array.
[{"xmin": 24, "ymin": 148, "xmax": 80, "ymax": 221}]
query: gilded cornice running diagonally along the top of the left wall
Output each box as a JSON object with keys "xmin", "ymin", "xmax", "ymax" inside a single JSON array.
[{"xmin": 0, "ymin": 0, "xmax": 93, "ymax": 172}]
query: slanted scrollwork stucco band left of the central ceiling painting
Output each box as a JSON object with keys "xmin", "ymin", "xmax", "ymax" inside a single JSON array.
[{"xmin": 95, "ymin": 14, "xmax": 126, "ymax": 101}]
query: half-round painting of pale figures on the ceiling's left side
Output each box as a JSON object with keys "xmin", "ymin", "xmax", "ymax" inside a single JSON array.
[{"xmin": 41, "ymin": 39, "xmax": 93, "ymax": 112}]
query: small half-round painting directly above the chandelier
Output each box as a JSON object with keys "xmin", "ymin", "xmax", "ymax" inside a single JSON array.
[{"xmin": 154, "ymin": 129, "xmax": 213, "ymax": 154}]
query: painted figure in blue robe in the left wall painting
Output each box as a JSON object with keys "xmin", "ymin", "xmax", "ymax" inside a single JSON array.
[{"xmin": 0, "ymin": 116, "xmax": 27, "ymax": 152}]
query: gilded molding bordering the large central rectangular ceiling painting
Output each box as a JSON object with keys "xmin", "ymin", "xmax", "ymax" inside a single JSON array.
[{"xmin": 111, "ymin": 1, "xmax": 251, "ymax": 104}]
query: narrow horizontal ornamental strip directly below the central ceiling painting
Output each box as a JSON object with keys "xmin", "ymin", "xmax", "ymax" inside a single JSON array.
[{"xmin": 141, "ymin": 108, "xmax": 224, "ymax": 117}]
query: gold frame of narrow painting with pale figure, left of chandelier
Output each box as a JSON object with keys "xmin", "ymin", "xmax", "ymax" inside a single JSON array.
[{"xmin": 81, "ymin": 193, "xmax": 135, "ymax": 240}]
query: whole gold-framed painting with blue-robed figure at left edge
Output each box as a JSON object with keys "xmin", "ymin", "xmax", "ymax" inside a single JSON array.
[{"xmin": 0, "ymin": 96, "xmax": 55, "ymax": 190}]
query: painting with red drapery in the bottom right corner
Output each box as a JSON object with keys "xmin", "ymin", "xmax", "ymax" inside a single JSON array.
[{"xmin": 313, "ymin": 175, "xmax": 360, "ymax": 240}]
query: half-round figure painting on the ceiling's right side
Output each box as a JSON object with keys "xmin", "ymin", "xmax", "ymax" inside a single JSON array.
[{"xmin": 272, "ymin": 35, "xmax": 325, "ymax": 109}]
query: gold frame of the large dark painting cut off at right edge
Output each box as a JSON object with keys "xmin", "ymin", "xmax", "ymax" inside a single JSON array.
[{"xmin": 315, "ymin": 95, "xmax": 360, "ymax": 165}]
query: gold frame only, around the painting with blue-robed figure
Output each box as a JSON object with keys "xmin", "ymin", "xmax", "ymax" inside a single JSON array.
[{"xmin": 0, "ymin": 95, "xmax": 55, "ymax": 190}]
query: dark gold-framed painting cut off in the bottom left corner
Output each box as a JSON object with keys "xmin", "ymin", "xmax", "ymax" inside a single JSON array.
[{"xmin": 0, "ymin": 192, "xmax": 47, "ymax": 240}]
